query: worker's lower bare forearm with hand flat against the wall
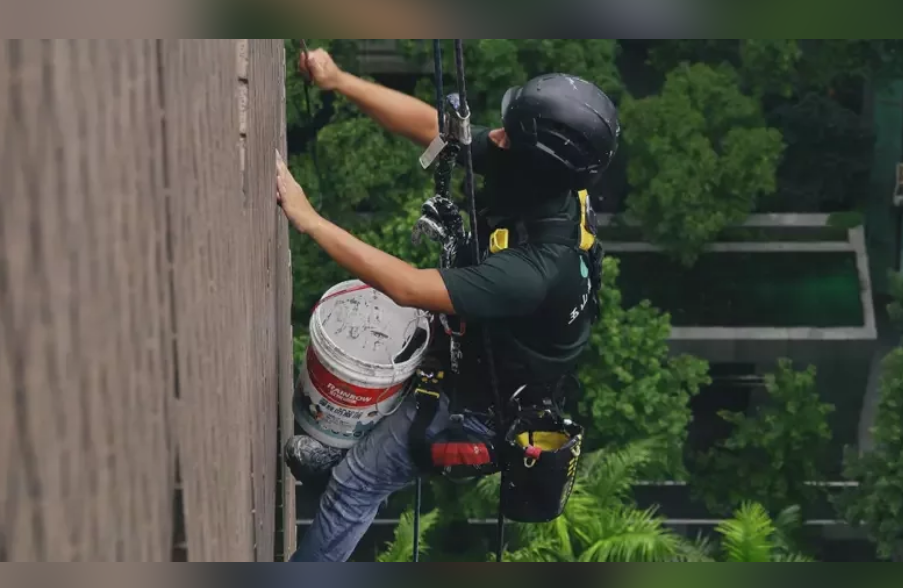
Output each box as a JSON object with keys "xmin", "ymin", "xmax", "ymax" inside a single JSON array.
[{"xmin": 276, "ymin": 153, "xmax": 455, "ymax": 315}]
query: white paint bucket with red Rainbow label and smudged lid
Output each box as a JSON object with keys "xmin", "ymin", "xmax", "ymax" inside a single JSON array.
[{"xmin": 295, "ymin": 280, "xmax": 430, "ymax": 449}]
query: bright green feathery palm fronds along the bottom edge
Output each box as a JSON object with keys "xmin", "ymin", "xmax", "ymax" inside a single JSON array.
[{"xmin": 377, "ymin": 442, "xmax": 812, "ymax": 563}]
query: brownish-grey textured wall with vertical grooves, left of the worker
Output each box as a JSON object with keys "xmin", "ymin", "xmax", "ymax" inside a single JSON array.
[{"xmin": 0, "ymin": 40, "xmax": 294, "ymax": 561}]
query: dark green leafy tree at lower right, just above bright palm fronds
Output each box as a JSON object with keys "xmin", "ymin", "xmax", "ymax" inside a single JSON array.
[{"xmin": 693, "ymin": 359, "xmax": 834, "ymax": 513}]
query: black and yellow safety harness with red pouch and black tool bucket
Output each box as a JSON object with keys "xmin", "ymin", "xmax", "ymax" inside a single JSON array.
[{"xmin": 409, "ymin": 191, "xmax": 602, "ymax": 522}]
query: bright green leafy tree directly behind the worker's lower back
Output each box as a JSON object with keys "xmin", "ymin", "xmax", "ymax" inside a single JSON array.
[{"xmin": 578, "ymin": 257, "xmax": 710, "ymax": 475}]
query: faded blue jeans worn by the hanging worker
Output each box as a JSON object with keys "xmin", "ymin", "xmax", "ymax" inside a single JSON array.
[{"xmin": 289, "ymin": 395, "xmax": 491, "ymax": 562}]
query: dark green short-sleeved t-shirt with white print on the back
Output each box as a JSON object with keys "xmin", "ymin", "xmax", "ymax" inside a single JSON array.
[{"xmin": 440, "ymin": 128, "xmax": 592, "ymax": 400}]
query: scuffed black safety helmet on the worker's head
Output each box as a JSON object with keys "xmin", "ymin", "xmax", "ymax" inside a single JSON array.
[{"xmin": 502, "ymin": 74, "xmax": 621, "ymax": 189}]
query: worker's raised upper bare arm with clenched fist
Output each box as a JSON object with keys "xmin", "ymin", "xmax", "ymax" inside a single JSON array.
[{"xmin": 299, "ymin": 49, "xmax": 439, "ymax": 147}]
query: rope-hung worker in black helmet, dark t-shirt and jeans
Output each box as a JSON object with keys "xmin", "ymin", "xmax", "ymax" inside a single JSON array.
[{"xmin": 276, "ymin": 49, "xmax": 620, "ymax": 562}]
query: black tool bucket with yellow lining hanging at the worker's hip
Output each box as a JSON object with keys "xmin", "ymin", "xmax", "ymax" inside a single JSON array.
[{"xmin": 500, "ymin": 408, "xmax": 583, "ymax": 523}]
